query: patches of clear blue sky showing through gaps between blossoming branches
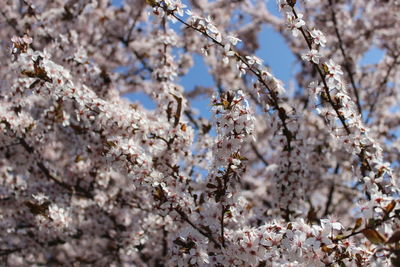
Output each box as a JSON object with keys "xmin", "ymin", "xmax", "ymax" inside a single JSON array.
[{"xmin": 112, "ymin": 0, "xmax": 383, "ymax": 117}]
